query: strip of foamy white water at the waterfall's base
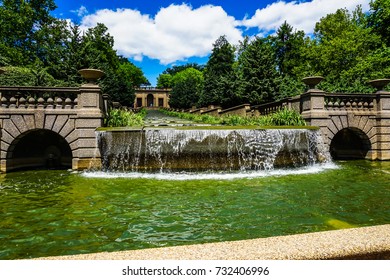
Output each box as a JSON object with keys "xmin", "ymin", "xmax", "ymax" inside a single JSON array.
[{"xmin": 81, "ymin": 162, "xmax": 339, "ymax": 181}]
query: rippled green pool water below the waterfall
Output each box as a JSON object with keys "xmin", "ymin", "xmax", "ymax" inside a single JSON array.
[{"xmin": 0, "ymin": 161, "xmax": 390, "ymax": 259}]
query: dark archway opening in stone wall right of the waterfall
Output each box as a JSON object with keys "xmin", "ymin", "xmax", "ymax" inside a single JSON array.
[{"xmin": 330, "ymin": 128, "xmax": 371, "ymax": 160}]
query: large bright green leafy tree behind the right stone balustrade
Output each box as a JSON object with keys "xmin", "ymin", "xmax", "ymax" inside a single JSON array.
[{"xmin": 309, "ymin": 7, "xmax": 382, "ymax": 92}]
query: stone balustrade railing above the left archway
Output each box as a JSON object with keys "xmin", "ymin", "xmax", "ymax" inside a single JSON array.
[{"xmin": 0, "ymin": 87, "xmax": 80, "ymax": 109}]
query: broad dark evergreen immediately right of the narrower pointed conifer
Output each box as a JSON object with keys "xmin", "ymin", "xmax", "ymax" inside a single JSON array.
[{"xmin": 237, "ymin": 37, "xmax": 280, "ymax": 104}]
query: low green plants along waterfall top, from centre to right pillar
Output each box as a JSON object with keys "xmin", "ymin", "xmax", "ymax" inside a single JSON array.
[{"xmin": 161, "ymin": 108, "xmax": 306, "ymax": 126}]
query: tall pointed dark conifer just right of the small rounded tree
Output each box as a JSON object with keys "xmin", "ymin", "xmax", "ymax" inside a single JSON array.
[{"xmin": 199, "ymin": 36, "xmax": 239, "ymax": 107}]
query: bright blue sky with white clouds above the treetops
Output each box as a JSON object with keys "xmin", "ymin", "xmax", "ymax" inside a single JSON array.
[{"xmin": 53, "ymin": 0, "xmax": 370, "ymax": 85}]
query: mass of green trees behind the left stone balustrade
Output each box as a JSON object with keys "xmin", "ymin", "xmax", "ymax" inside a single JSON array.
[{"xmin": 0, "ymin": 0, "xmax": 149, "ymax": 106}]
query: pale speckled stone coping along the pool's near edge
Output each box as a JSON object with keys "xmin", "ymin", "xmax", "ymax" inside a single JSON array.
[{"xmin": 34, "ymin": 224, "xmax": 390, "ymax": 260}]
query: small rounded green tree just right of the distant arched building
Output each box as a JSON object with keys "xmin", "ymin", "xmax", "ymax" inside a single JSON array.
[{"xmin": 169, "ymin": 68, "xmax": 203, "ymax": 109}]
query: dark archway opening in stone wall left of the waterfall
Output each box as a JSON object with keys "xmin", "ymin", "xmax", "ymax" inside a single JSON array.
[{"xmin": 7, "ymin": 129, "xmax": 72, "ymax": 169}]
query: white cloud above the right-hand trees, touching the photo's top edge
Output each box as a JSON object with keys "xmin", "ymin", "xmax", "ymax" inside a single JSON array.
[{"xmin": 241, "ymin": 0, "xmax": 370, "ymax": 33}]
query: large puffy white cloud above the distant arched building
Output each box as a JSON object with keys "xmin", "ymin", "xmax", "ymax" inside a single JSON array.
[{"xmin": 81, "ymin": 4, "xmax": 242, "ymax": 64}]
